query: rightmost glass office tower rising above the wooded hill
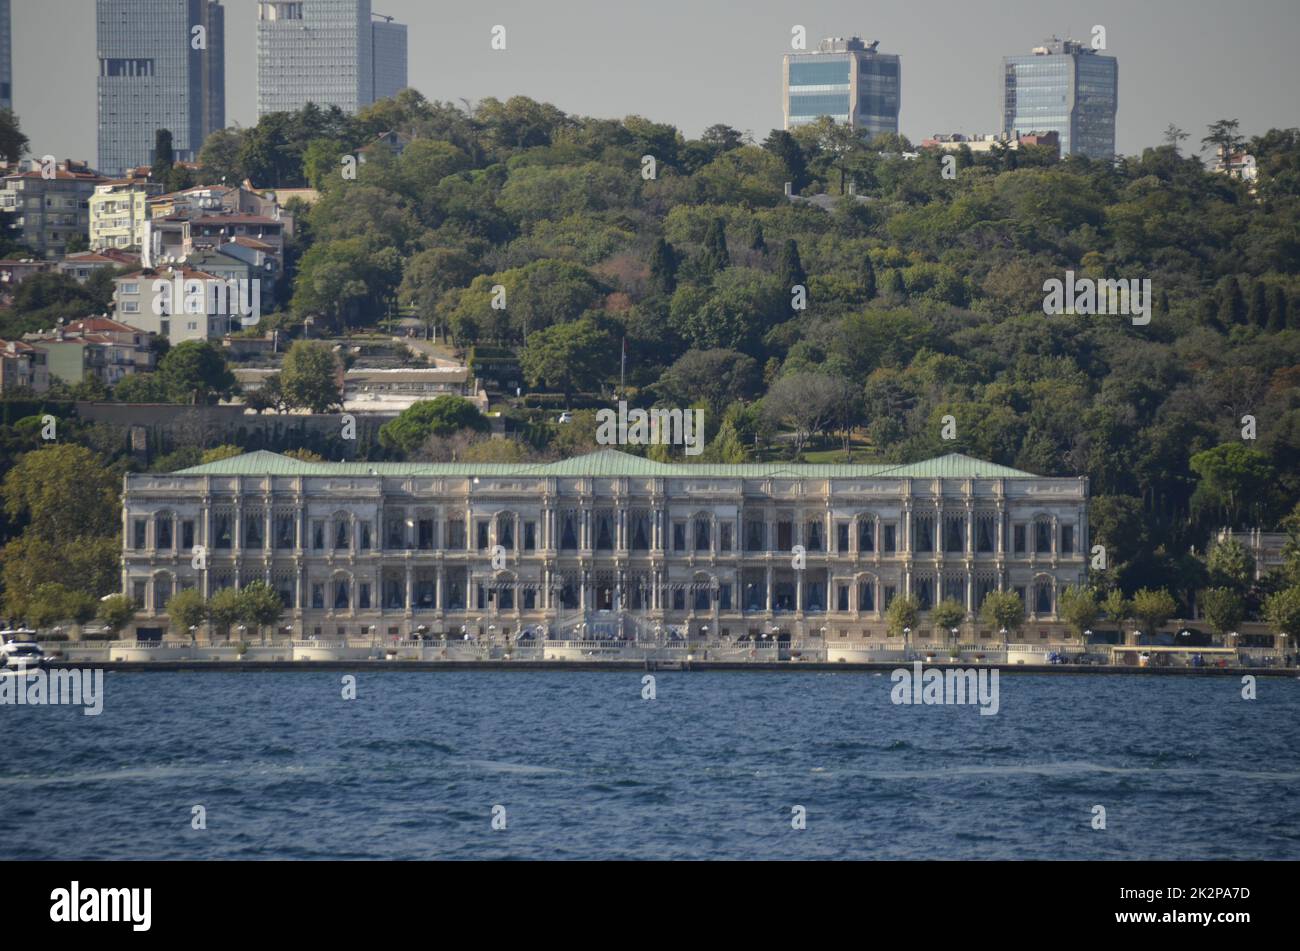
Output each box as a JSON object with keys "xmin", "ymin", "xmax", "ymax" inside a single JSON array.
[{"xmin": 1002, "ymin": 36, "xmax": 1119, "ymax": 159}]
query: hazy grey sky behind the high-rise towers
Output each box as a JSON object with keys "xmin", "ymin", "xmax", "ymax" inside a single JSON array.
[{"xmin": 13, "ymin": 0, "xmax": 1300, "ymax": 161}]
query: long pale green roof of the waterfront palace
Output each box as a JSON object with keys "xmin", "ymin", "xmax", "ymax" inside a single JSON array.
[{"xmin": 179, "ymin": 450, "xmax": 1039, "ymax": 479}]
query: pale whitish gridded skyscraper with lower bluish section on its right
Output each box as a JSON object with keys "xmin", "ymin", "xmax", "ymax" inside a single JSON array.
[{"xmin": 257, "ymin": 0, "xmax": 406, "ymax": 116}]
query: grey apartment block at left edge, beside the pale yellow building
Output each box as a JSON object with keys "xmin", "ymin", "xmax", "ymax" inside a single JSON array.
[{"xmin": 0, "ymin": 160, "xmax": 104, "ymax": 257}]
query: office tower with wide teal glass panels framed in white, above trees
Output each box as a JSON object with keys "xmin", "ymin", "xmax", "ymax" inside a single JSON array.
[{"xmin": 783, "ymin": 36, "xmax": 902, "ymax": 139}]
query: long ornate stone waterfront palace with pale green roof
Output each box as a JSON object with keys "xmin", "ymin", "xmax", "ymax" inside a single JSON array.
[{"xmin": 122, "ymin": 450, "xmax": 1088, "ymax": 639}]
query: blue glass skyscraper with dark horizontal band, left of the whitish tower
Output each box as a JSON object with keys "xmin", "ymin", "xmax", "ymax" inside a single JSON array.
[{"xmin": 95, "ymin": 0, "xmax": 226, "ymax": 175}]
